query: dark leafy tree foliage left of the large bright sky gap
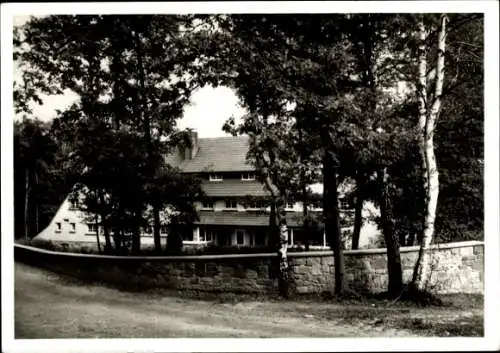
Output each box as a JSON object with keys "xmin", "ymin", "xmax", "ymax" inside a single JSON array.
[{"xmin": 15, "ymin": 15, "xmax": 206, "ymax": 251}]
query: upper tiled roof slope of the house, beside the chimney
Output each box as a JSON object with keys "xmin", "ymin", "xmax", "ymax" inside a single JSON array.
[{"xmin": 179, "ymin": 136, "xmax": 254, "ymax": 173}]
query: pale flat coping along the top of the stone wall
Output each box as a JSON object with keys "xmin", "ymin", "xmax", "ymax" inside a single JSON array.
[{"xmin": 14, "ymin": 240, "xmax": 484, "ymax": 261}]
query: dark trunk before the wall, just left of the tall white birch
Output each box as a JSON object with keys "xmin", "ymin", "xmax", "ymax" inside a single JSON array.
[{"xmin": 378, "ymin": 168, "xmax": 403, "ymax": 297}]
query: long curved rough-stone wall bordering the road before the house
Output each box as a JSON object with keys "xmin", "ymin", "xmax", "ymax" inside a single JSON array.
[{"xmin": 15, "ymin": 242, "xmax": 484, "ymax": 294}]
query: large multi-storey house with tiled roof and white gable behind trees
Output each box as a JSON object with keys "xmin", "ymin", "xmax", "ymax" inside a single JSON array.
[{"xmin": 37, "ymin": 132, "xmax": 375, "ymax": 247}]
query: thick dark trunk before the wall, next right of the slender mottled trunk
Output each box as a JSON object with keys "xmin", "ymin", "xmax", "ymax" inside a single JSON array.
[{"xmin": 323, "ymin": 151, "xmax": 346, "ymax": 294}]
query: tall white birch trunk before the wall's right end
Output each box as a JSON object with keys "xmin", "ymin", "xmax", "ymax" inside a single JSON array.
[{"xmin": 413, "ymin": 16, "xmax": 447, "ymax": 291}]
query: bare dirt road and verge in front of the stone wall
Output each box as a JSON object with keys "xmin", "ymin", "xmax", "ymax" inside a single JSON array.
[{"xmin": 15, "ymin": 263, "xmax": 483, "ymax": 338}]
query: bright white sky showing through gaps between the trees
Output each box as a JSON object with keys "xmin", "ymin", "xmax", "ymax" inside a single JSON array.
[{"xmin": 14, "ymin": 16, "xmax": 245, "ymax": 137}]
